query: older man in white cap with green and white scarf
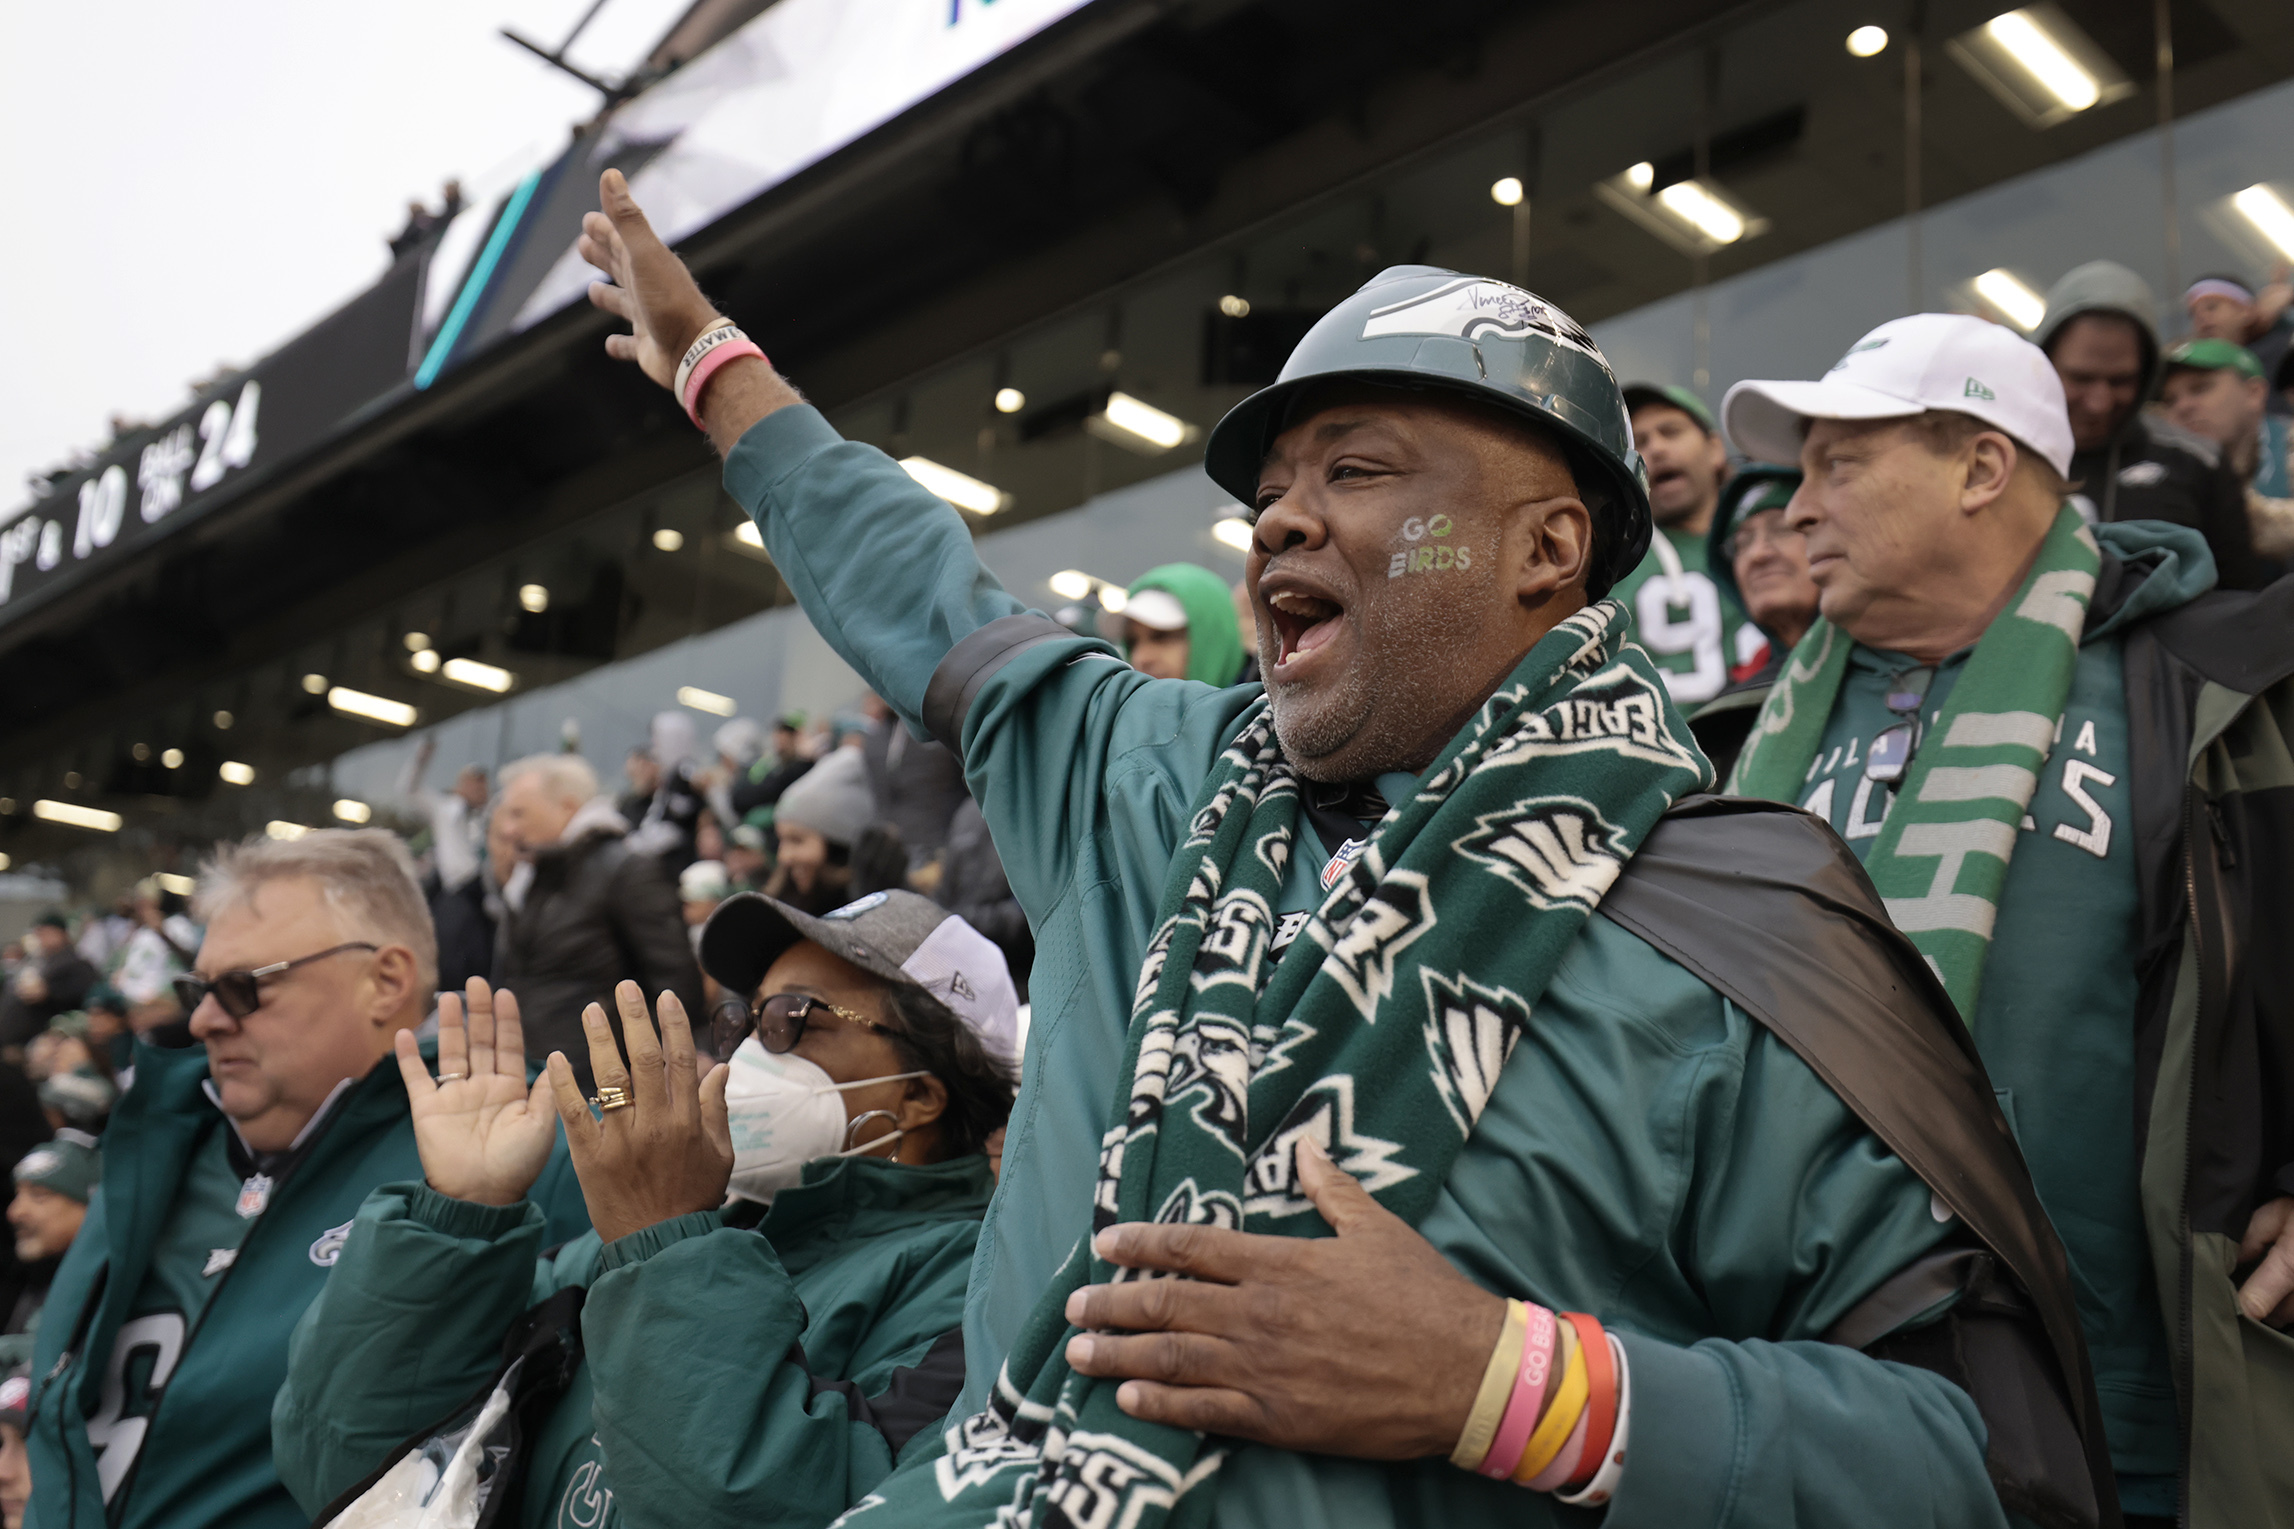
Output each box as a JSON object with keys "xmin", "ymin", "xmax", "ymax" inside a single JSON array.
[{"xmin": 1723, "ymin": 314, "xmax": 2294, "ymax": 1527}]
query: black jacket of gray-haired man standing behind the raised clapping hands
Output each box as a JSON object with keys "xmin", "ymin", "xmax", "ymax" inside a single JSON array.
[{"xmin": 493, "ymin": 828, "xmax": 707, "ymax": 1091}]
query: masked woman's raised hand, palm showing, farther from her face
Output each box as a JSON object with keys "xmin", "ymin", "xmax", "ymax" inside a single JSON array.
[{"xmin": 397, "ymin": 977, "xmax": 557, "ymax": 1206}]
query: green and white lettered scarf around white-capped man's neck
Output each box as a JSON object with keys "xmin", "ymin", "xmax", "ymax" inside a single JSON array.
[{"xmin": 1727, "ymin": 504, "xmax": 2101, "ymax": 1018}]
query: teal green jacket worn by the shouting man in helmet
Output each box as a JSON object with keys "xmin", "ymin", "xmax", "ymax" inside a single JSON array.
[{"xmin": 725, "ymin": 408, "xmax": 2003, "ymax": 1529}]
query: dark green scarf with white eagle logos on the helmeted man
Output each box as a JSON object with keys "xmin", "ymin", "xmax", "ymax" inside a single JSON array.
[{"xmin": 840, "ymin": 601, "xmax": 1711, "ymax": 1529}]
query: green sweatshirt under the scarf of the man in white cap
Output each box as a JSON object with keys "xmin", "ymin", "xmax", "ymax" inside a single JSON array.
[{"xmin": 1798, "ymin": 635, "xmax": 2182, "ymax": 1513}]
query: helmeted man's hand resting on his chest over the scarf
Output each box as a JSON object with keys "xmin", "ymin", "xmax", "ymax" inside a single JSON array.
[{"xmin": 1067, "ymin": 1142, "xmax": 1505, "ymax": 1460}]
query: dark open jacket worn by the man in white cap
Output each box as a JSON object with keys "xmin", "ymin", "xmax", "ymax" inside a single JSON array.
[{"xmin": 1695, "ymin": 523, "xmax": 2294, "ymax": 1529}]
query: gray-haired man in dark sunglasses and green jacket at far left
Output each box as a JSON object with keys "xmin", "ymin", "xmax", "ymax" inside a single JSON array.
[{"xmin": 28, "ymin": 830, "xmax": 587, "ymax": 1529}]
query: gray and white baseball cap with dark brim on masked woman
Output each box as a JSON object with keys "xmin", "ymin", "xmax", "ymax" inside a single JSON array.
[{"xmin": 702, "ymin": 892, "xmax": 1019, "ymax": 1061}]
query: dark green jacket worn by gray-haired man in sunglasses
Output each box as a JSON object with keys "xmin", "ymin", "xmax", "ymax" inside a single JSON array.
[{"xmin": 25, "ymin": 1045, "xmax": 590, "ymax": 1529}]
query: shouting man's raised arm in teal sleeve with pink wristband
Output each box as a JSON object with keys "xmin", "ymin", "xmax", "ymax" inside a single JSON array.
[{"xmin": 580, "ymin": 170, "xmax": 1253, "ymax": 919}]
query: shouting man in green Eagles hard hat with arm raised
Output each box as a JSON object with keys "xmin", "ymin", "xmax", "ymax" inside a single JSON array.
[{"xmin": 555, "ymin": 172, "xmax": 2117, "ymax": 1529}]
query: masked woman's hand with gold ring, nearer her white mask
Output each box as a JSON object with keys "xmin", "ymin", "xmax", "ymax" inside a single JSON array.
[{"xmin": 548, "ymin": 981, "xmax": 732, "ymax": 1242}]
